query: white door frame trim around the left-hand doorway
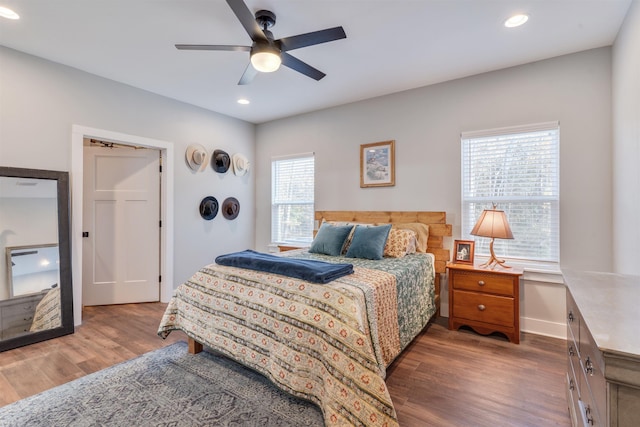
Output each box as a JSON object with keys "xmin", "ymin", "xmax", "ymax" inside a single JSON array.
[{"xmin": 71, "ymin": 125, "xmax": 174, "ymax": 326}]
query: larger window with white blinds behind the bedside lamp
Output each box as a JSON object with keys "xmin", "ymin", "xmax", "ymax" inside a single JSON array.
[{"xmin": 461, "ymin": 122, "xmax": 560, "ymax": 263}]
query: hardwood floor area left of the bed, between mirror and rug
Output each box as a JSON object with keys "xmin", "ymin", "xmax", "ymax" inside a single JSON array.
[{"xmin": 0, "ymin": 303, "xmax": 186, "ymax": 406}]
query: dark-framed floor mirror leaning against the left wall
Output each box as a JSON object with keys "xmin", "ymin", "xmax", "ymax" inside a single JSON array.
[{"xmin": 0, "ymin": 166, "xmax": 73, "ymax": 351}]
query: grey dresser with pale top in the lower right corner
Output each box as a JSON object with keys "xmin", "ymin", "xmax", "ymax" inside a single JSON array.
[{"xmin": 563, "ymin": 271, "xmax": 640, "ymax": 427}]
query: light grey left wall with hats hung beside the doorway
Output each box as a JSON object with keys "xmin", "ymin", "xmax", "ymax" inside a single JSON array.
[{"xmin": 0, "ymin": 47, "xmax": 255, "ymax": 321}]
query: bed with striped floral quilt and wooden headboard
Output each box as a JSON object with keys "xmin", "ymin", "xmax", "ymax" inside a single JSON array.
[{"xmin": 158, "ymin": 211, "xmax": 451, "ymax": 426}]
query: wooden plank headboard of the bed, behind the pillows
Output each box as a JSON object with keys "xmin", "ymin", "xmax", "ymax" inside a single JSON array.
[{"xmin": 315, "ymin": 211, "xmax": 452, "ymax": 307}]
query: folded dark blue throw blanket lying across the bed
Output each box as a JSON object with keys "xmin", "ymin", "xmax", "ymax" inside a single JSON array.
[{"xmin": 216, "ymin": 249, "xmax": 353, "ymax": 284}]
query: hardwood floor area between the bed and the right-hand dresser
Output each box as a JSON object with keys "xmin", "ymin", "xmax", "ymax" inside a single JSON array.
[{"xmin": 387, "ymin": 318, "xmax": 571, "ymax": 427}]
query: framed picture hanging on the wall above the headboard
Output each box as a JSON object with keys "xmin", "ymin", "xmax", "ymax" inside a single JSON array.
[{"xmin": 360, "ymin": 141, "xmax": 396, "ymax": 188}]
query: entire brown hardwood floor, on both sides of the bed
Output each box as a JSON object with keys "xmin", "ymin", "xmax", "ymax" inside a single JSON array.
[{"xmin": 0, "ymin": 303, "xmax": 570, "ymax": 427}]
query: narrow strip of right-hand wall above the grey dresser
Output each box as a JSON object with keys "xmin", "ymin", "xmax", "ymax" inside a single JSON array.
[{"xmin": 613, "ymin": 0, "xmax": 640, "ymax": 275}]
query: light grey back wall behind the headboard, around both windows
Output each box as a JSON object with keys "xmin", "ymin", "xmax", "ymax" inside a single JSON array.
[{"xmin": 255, "ymin": 48, "xmax": 612, "ymax": 336}]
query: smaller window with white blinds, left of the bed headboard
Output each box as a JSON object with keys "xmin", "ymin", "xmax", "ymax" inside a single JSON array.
[{"xmin": 271, "ymin": 153, "xmax": 314, "ymax": 246}]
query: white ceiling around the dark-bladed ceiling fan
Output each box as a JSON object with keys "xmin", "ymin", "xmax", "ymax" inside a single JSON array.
[{"xmin": 0, "ymin": 0, "xmax": 631, "ymax": 123}]
